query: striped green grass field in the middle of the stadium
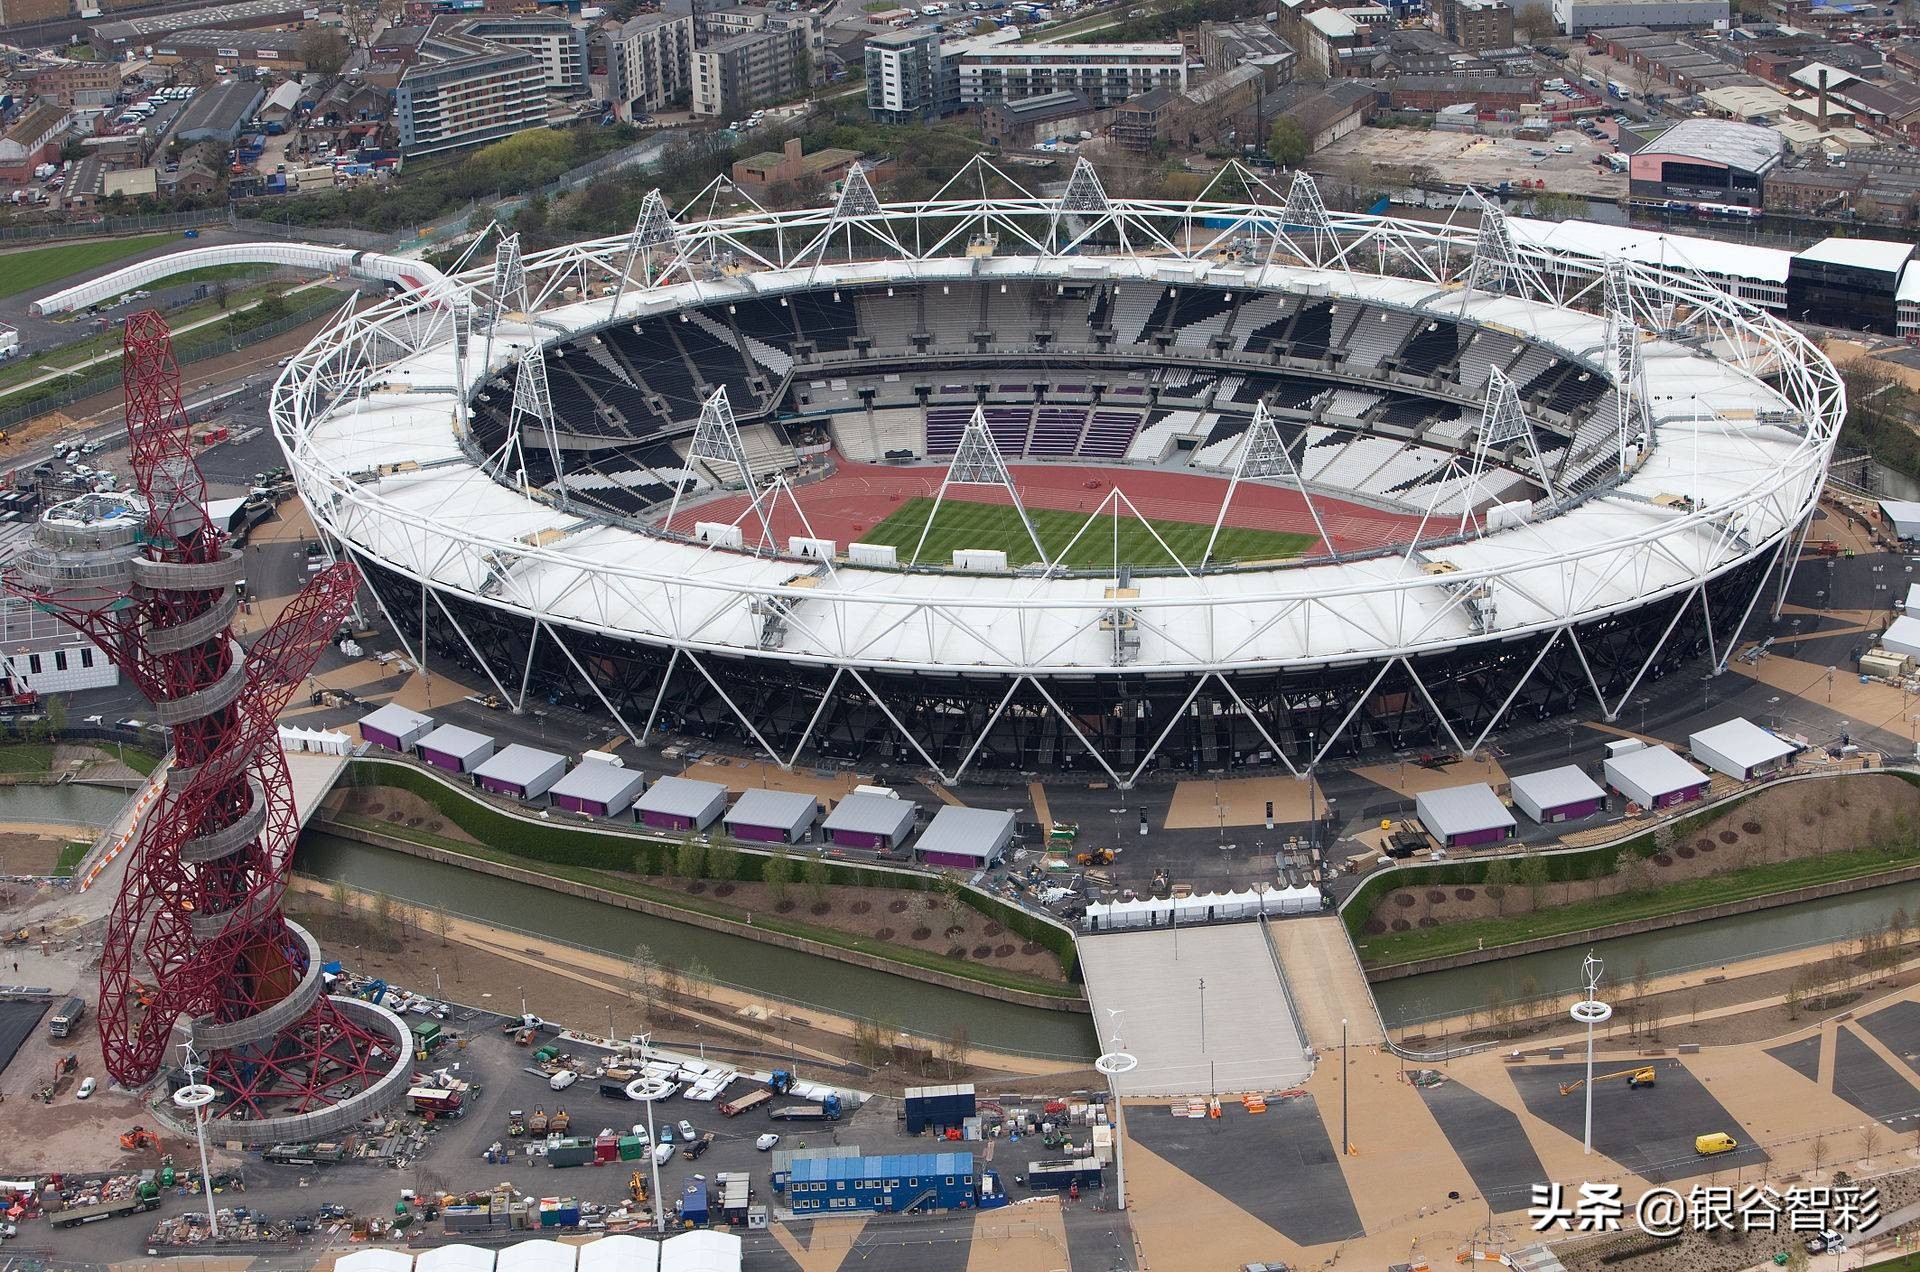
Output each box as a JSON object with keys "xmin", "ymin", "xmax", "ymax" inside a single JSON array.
[{"xmin": 860, "ymin": 498, "xmax": 1315, "ymax": 569}]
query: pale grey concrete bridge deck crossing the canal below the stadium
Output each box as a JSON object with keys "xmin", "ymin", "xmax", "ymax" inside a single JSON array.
[{"xmin": 1079, "ymin": 922, "xmax": 1313, "ymax": 1095}]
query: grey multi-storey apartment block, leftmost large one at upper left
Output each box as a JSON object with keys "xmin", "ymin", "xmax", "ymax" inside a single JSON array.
[{"xmin": 394, "ymin": 19, "xmax": 547, "ymax": 156}]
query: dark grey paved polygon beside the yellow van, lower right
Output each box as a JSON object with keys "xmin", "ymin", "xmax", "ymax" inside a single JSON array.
[{"xmin": 1507, "ymin": 1061, "xmax": 1766, "ymax": 1184}]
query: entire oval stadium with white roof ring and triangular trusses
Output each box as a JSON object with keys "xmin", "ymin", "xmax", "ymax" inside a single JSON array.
[{"xmin": 273, "ymin": 161, "xmax": 1845, "ymax": 786}]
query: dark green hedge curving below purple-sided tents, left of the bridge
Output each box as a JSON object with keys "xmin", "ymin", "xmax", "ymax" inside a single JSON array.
[{"xmin": 334, "ymin": 759, "xmax": 1079, "ymax": 980}]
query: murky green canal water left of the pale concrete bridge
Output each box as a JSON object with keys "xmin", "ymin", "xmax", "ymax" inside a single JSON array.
[{"xmin": 294, "ymin": 832, "xmax": 1098, "ymax": 1061}]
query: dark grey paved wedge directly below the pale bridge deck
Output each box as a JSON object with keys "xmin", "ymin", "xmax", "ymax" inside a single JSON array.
[{"xmin": 1127, "ymin": 1095, "xmax": 1359, "ymax": 1245}]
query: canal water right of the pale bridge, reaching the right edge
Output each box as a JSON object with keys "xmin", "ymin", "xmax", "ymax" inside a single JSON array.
[{"xmin": 1373, "ymin": 882, "xmax": 1920, "ymax": 1028}]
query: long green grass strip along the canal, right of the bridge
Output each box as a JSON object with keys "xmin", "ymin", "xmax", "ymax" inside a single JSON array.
[{"xmin": 1356, "ymin": 847, "xmax": 1916, "ymax": 966}]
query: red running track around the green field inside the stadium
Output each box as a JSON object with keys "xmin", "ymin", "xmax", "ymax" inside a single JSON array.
[{"xmin": 672, "ymin": 457, "xmax": 1419, "ymax": 551}]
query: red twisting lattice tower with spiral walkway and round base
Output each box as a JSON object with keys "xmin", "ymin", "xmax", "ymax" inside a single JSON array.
[{"xmin": 6, "ymin": 311, "xmax": 413, "ymax": 1139}]
